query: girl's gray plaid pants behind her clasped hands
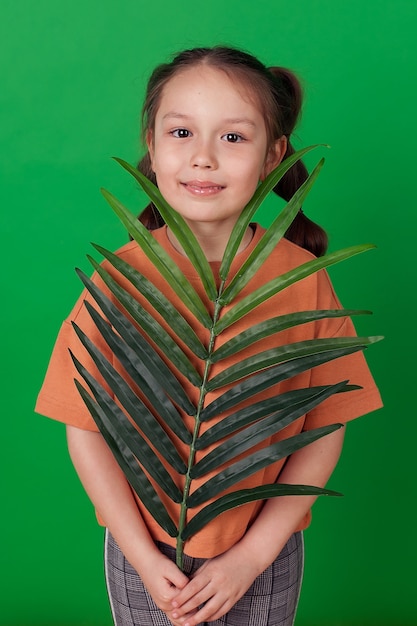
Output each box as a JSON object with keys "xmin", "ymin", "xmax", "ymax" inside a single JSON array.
[{"xmin": 105, "ymin": 531, "xmax": 304, "ymax": 626}]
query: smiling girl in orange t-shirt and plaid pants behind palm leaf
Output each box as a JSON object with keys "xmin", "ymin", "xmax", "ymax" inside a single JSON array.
[{"xmin": 37, "ymin": 47, "xmax": 381, "ymax": 626}]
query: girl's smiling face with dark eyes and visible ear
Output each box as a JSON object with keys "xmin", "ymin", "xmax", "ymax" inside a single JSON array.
[{"xmin": 148, "ymin": 65, "xmax": 286, "ymax": 231}]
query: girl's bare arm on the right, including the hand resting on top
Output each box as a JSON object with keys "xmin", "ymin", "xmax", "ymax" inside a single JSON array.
[{"xmin": 172, "ymin": 428, "xmax": 344, "ymax": 626}]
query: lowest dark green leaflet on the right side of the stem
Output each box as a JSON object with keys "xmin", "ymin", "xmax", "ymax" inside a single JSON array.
[{"xmin": 182, "ymin": 483, "xmax": 342, "ymax": 541}]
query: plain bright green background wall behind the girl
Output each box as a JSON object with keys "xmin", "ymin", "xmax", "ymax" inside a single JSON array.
[{"xmin": 0, "ymin": 0, "xmax": 417, "ymax": 626}]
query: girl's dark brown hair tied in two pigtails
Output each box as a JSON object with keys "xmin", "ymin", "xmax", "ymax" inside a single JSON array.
[{"xmin": 138, "ymin": 46, "xmax": 327, "ymax": 256}]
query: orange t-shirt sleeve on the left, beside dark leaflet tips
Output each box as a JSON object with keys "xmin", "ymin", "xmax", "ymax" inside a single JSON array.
[{"xmin": 35, "ymin": 280, "xmax": 112, "ymax": 431}]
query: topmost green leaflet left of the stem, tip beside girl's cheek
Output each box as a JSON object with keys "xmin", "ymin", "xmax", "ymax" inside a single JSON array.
[{"xmin": 110, "ymin": 158, "xmax": 217, "ymax": 302}]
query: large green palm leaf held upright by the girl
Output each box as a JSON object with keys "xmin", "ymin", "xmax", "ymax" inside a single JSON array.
[{"xmin": 74, "ymin": 148, "xmax": 379, "ymax": 567}]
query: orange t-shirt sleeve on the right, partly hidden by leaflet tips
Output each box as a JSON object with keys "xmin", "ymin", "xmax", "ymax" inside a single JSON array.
[{"xmin": 304, "ymin": 272, "xmax": 382, "ymax": 430}]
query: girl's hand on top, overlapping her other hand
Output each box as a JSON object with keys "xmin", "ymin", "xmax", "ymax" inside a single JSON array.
[{"xmin": 168, "ymin": 546, "xmax": 260, "ymax": 626}]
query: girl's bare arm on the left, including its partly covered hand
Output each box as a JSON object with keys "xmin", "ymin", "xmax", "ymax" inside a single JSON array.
[{"xmin": 67, "ymin": 426, "xmax": 188, "ymax": 621}]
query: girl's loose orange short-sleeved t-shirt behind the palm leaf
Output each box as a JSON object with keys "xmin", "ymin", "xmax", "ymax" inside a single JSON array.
[{"xmin": 36, "ymin": 225, "xmax": 381, "ymax": 558}]
